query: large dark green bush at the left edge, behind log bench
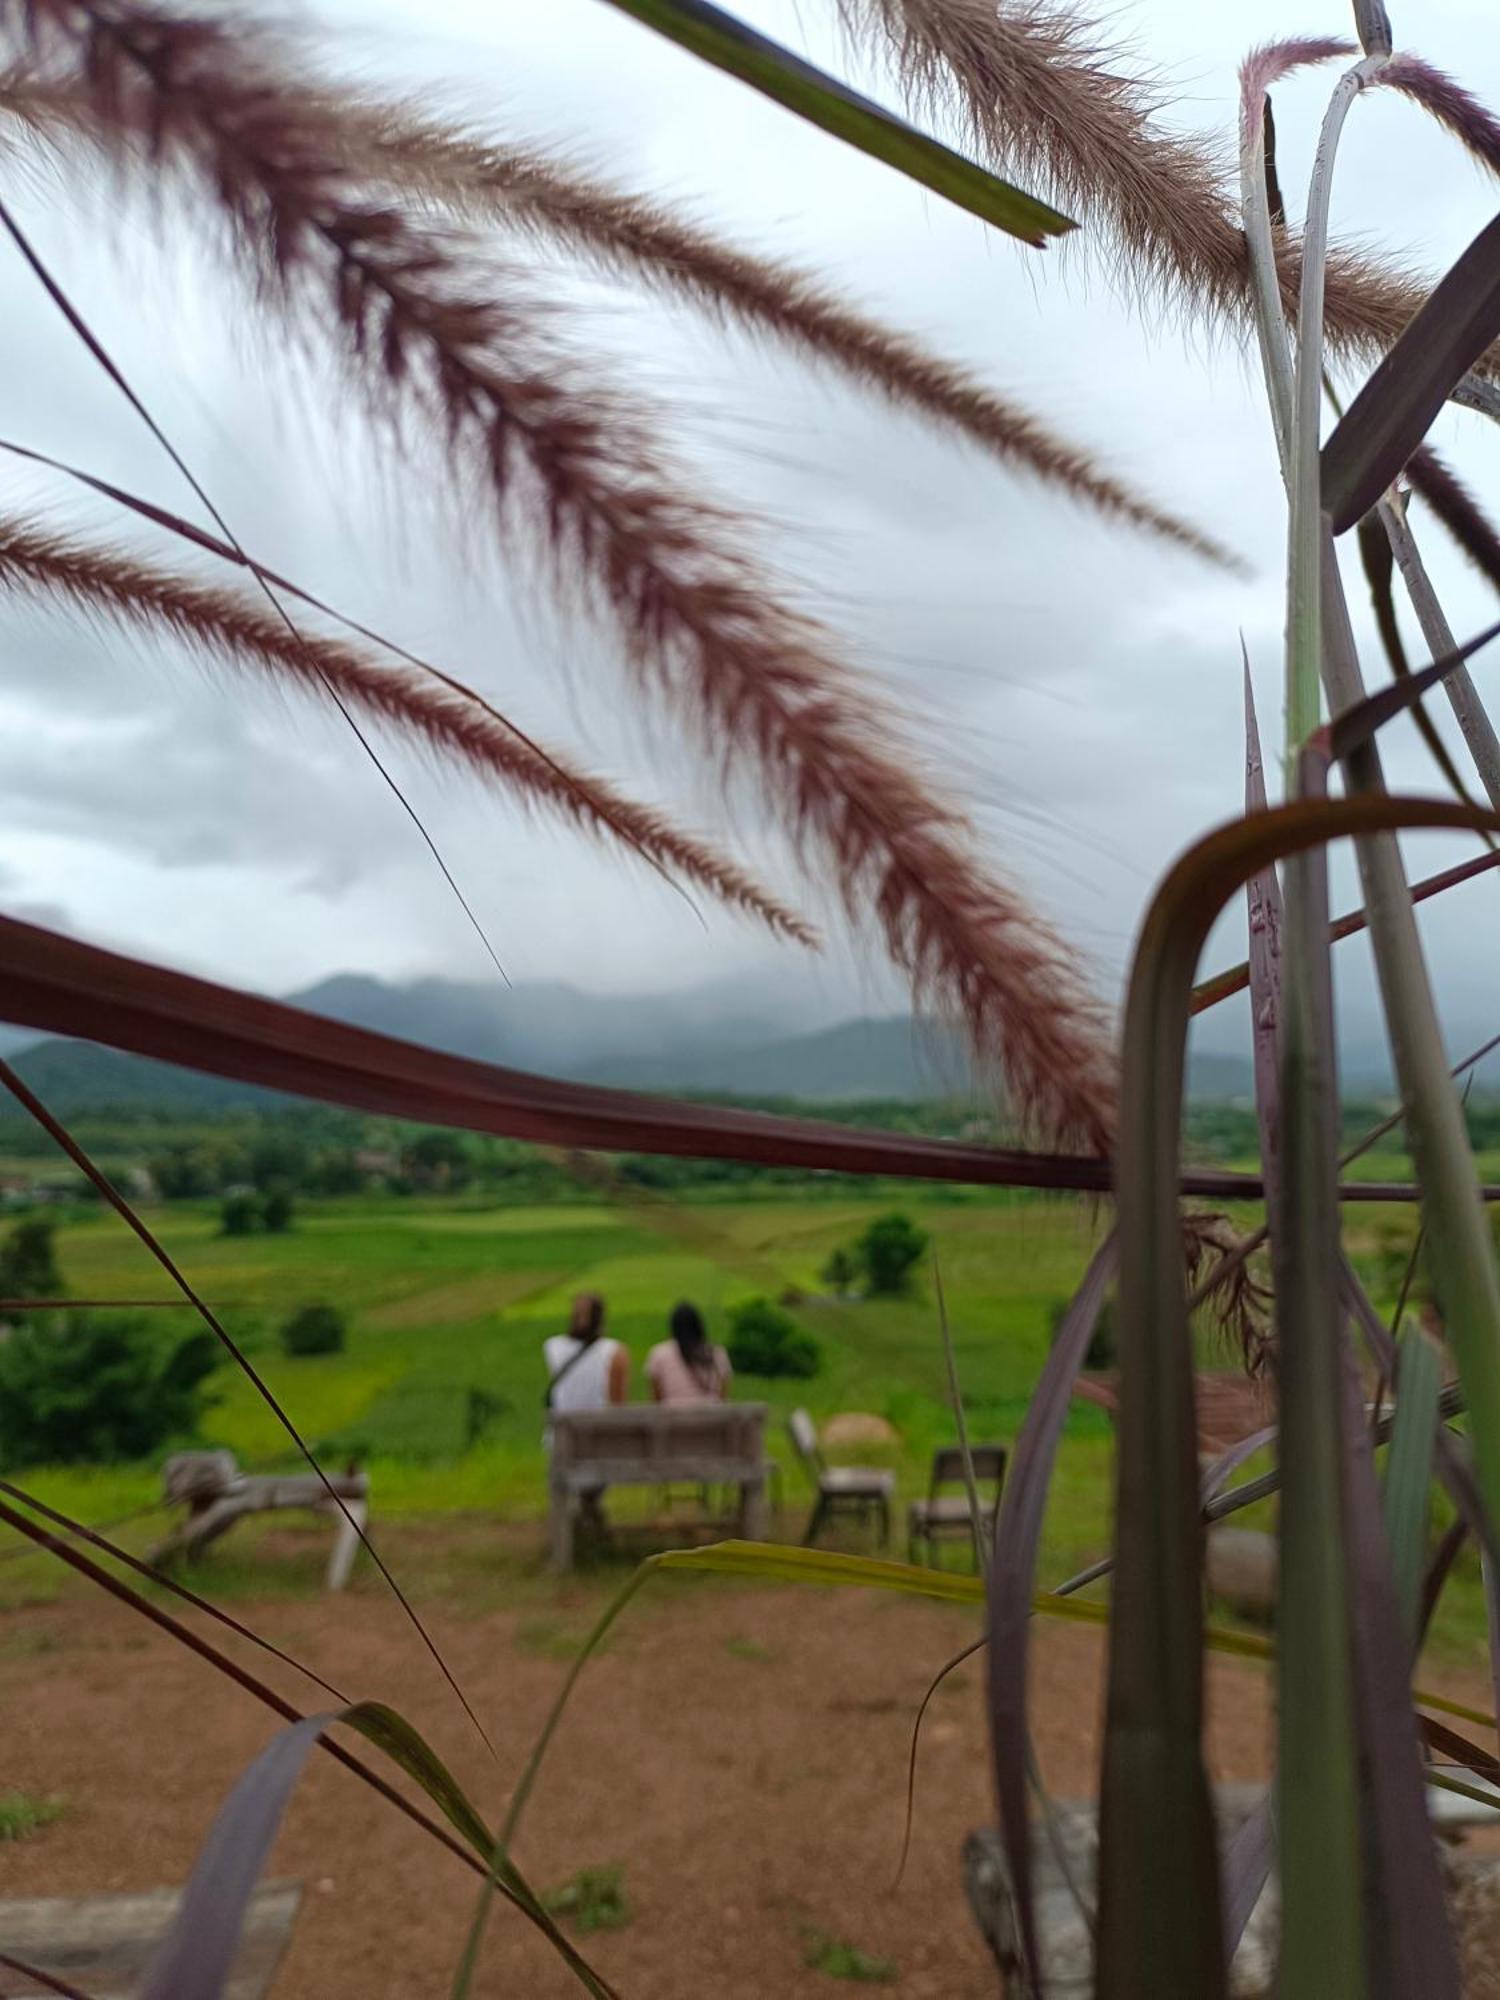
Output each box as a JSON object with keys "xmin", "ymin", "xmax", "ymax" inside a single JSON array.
[{"xmin": 0, "ymin": 1312, "xmax": 218, "ymax": 1468}]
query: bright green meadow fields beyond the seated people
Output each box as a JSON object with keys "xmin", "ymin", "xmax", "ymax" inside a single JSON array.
[{"xmin": 5, "ymin": 1156, "xmax": 1482, "ymax": 1646}]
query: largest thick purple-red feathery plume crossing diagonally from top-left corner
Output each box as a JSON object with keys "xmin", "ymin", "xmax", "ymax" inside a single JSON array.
[{"xmin": 0, "ymin": 0, "xmax": 1114, "ymax": 1150}]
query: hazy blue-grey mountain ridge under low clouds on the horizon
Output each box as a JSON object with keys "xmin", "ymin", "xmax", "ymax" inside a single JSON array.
[{"xmin": 0, "ymin": 974, "xmax": 1272, "ymax": 1116}]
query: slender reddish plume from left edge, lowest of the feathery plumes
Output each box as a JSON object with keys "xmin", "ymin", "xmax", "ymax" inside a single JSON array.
[{"xmin": 0, "ymin": 516, "xmax": 816, "ymax": 944}]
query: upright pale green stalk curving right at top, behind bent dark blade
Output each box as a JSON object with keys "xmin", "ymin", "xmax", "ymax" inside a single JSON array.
[{"xmin": 1262, "ymin": 64, "xmax": 1366, "ymax": 1976}]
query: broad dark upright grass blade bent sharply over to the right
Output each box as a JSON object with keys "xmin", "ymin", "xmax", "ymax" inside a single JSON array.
[{"xmin": 1098, "ymin": 796, "xmax": 1500, "ymax": 1994}]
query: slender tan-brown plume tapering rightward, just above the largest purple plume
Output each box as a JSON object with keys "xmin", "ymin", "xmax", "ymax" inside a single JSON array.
[{"xmin": 282, "ymin": 100, "xmax": 1234, "ymax": 564}]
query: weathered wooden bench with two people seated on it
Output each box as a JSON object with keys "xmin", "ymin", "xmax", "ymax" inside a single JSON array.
[{"xmin": 548, "ymin": 1402, "xmax": 770, "ymax": 1570}]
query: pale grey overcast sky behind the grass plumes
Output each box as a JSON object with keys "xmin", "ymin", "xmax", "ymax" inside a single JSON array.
[{"xmin": 0, "ymin": 0, "xmax": 1500, "ymax": 1064}]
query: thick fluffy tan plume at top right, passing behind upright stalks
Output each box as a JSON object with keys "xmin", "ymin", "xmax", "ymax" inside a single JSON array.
[{"xmin": 834, "ymin": 0, "xmax": 1500, "ymax": 372}]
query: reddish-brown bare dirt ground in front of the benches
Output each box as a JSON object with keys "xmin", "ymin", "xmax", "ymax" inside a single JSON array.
[{"xmin": 0, "ymin": 1530, "xmax": 1496, "ymax": 2000}]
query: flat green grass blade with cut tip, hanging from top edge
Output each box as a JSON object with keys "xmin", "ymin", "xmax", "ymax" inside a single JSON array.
[{"xmin": 592, "ymin": 0, "xmax": 1078, "ymax": 248}]
